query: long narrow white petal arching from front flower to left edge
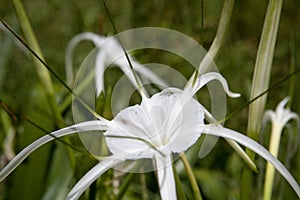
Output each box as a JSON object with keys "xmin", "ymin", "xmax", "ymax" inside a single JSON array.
[{"xmin": 0, "ymin": 120, "xmax": 107, "ymax": 181}]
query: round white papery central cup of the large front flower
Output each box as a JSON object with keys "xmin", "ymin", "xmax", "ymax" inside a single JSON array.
[{"xmin": 106, "ymin": 91, "xmax": 204, "ymax": 159}]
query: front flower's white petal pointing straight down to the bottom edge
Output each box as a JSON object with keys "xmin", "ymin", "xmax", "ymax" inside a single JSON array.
[{"xmin": 155, "ymin": 155, "xmax": 177, "ymax": 200}]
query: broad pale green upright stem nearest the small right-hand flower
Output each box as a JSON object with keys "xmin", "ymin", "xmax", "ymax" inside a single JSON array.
[{"xmin": 241, "ymin": 0, "xmax": 282, "ymax": 199}]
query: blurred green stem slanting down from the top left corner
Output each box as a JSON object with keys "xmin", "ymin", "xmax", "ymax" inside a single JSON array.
[{"xmin": 13, "ymin": 0, "xmax": 65, "ymax": 128}]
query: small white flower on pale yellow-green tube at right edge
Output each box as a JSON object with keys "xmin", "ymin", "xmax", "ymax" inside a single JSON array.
[{"xmin": 264, "ymin": 97, "xmax": 299, "ymax": 200}]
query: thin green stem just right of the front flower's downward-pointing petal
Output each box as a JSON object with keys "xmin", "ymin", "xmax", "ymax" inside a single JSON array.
[{"xmin": 180, "ymin": 153, "xmax": 202, "ymax": 200}]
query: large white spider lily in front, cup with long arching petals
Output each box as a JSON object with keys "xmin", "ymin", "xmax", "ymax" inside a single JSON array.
[{"xmin": 0, "ymin": 72, "xmax": 300, "ymax": 200}]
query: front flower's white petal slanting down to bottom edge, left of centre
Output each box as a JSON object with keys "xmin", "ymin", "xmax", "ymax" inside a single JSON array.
[{"xmin": 66, "ymin": 157, "xmax": 120, "ymax": 200}]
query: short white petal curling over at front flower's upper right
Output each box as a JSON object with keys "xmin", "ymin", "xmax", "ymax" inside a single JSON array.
[{"xmin": 192, "ymin": 72, "xmax": 240, "ymax": 98}]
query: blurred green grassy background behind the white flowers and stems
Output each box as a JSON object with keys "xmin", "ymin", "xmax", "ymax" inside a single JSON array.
[{"xmin": 0, "ymin": 0, "xmax": 300, "ymax": 199}]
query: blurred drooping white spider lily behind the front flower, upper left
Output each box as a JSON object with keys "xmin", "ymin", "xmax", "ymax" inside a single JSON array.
[{"xmin": 65, "ymin": 32, "xmax": 167, "ymax": 97}]
